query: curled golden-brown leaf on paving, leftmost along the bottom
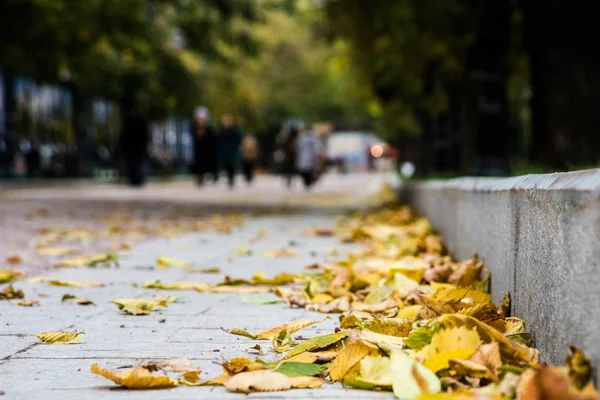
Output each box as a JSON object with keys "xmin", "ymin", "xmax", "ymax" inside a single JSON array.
[{"xmin": 92, "ymin": 364, "xmax": 179, "ymax": 389}]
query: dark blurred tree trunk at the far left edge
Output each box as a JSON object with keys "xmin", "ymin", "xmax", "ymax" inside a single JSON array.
[{"xmin": 0, "ymin": 69, "xmax": 18, "ymax": 177}]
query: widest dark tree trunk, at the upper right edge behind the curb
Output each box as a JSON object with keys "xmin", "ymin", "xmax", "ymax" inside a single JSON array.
[{"xmin": 521, "ymin": 0, "xmax": 600, "ymax": 169}]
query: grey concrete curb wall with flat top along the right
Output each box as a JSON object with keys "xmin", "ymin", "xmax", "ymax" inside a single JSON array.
[{"xmin": 400, "ymin": 169, "xmax": 600, "ymax": 382}]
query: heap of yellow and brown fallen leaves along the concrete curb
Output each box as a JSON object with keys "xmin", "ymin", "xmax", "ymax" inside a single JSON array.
[{"xmin": 79, "ymin": 207, "xmax": 599, "ymax": 400}]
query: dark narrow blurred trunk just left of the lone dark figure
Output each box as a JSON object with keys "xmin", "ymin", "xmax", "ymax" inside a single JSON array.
[{"xmin": 69, "ymin": 83, "xmax": 94, "ymax": 177}]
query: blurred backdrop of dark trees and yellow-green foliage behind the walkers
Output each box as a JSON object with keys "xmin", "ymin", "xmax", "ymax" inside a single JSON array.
[{"xmin": 0, "ymin": 0, "xmax": 600, "ymax": 178}]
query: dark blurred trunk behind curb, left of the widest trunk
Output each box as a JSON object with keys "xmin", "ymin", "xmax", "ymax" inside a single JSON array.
[{"xmin": 468, "ymin": 0, "xmax": 511, "ymax": 175}]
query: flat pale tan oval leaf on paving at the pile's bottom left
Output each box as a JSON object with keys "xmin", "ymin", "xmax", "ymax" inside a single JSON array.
[{"xmin": 225, "ymin": 370, "xmax": 292, "ymax": 393}]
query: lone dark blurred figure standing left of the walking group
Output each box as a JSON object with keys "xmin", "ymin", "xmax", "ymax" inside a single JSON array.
[{"xmin": 120, "ymin": 97, "xmax": 150, "ymax": 186}]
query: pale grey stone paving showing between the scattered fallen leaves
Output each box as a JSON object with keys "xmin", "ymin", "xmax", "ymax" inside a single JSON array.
[{"xmin": 0, "ymin": 173, "xmax": 400, "ymax": 400}]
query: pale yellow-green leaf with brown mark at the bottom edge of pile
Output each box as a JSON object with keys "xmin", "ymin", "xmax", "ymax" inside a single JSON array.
[{"xmin": 390, "ymin": 347, "xmax": 442, "ymax": 400}]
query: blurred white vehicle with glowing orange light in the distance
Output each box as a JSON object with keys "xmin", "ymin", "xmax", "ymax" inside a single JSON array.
[{"xmin": 327, "ymin": 131, "xmax": 398, "ymax": 172}]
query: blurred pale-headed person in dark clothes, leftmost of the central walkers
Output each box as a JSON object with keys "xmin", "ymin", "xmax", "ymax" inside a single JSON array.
[{"xmin": 192, "ymin": 107, "xmax": 219, "ymax": 185}]
